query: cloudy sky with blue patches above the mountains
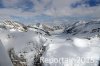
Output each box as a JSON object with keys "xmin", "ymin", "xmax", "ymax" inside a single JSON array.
[{"xmin": 0, "ymin": 0, "xmax": 100, "ymax": 23}]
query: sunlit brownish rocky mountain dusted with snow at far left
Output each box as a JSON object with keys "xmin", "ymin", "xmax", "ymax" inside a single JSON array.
[{"xmin": 0, "ymin": 21, "xmax": 27, "ymax": 31}]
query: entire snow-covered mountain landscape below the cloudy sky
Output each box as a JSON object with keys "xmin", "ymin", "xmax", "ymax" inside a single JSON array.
[{"xmin": 0, "ymin": 21, "xmax": 100, "ymax": 66}]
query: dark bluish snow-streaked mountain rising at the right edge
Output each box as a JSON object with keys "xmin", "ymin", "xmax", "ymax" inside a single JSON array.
[{"xmin": 64, "ymin": 21, "xmax": 100, "ymax": 35}]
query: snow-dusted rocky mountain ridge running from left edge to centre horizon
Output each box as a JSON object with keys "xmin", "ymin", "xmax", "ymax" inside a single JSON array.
[{"xmin": 0, "ymin": 21, "xmax": 63, "ymax": 35}]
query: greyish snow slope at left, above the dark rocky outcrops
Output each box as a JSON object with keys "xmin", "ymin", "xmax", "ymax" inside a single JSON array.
[{"xmin": 0, "ymin": 30, "xmax": 46, "ymax": 65}]
